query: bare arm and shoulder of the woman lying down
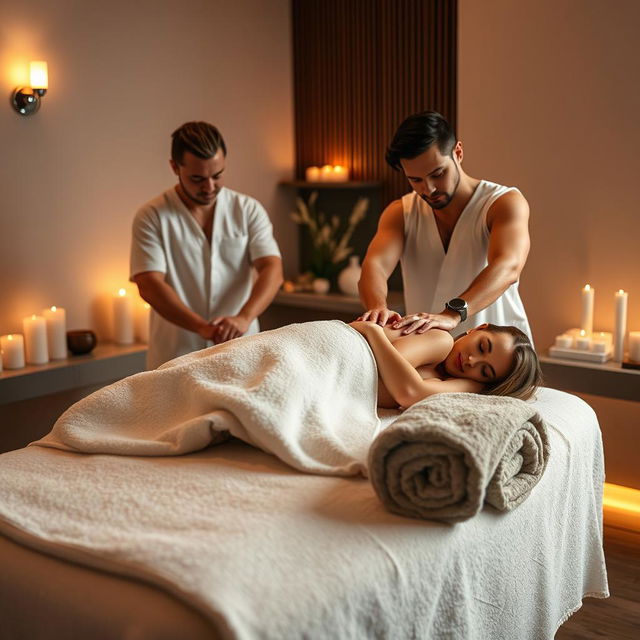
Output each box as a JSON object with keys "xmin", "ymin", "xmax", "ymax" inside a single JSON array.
[{"xmin": 351, "ymin": 322, "xmax": 482, "ymax": 407}]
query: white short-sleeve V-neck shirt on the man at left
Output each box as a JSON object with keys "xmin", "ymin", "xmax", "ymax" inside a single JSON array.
[{"xmin": 130, "ymin": 187, "xmax": 280, "ymax": 369}]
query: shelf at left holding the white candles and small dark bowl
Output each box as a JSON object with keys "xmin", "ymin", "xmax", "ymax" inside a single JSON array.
[{"xmin": 0, "ymin": 343, "xmax": 147, "ymax": 405}]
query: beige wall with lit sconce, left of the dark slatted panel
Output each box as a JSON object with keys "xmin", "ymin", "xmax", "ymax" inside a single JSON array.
[{"xmin": 0, "ymin": 0, "xmax": 293, "ymax": 334}]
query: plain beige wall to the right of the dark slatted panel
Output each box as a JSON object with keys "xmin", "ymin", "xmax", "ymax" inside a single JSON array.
[{"xmin": 458, "ymin": 0, "xmax": 640, "ymax": 487}]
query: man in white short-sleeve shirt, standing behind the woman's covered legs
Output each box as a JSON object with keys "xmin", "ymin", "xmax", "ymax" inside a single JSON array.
[{"xmin": 130, "ymin": 122, "xmax": 282, "ymax": 369}]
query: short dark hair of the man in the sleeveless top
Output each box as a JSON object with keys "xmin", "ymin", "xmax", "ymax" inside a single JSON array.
[{"xmin": 385, "ymin": 111, "xmax": 456, "ymax": 171}]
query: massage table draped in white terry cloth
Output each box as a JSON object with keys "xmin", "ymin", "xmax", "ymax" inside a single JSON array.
[{"xmin": 0, "ymin": 388, "xmax": 608, "ymax": 640}]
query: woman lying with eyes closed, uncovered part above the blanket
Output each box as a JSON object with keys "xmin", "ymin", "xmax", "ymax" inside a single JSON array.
[{"xmin": 350, "ymin": 321, "xmax": 542, "ymax": 409}]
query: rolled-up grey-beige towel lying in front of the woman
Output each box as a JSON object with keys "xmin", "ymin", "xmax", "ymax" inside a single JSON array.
[{"xmin": 369, "ymin": 393, "xmax": 549, "ymax": 522}]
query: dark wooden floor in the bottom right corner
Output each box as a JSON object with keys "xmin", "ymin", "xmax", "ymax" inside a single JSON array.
[{"xmin": 556, "ymin": 527, "xmax": 640, "ymax": 640}]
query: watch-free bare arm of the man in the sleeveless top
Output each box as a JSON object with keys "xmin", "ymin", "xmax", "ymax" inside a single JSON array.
[{"xmin": 358, "ymin": 200, "xmax": 404, "ymax": 326}]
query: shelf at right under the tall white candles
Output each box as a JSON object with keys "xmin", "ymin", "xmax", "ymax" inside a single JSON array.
[{"xmin": 540, "ymin": 355, "xmax": 640, "ymax": 402}]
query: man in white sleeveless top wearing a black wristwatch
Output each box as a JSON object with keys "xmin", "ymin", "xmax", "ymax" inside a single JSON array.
[{"xmin": 359, "ymin": 111, "xmax": 531, "ymax": 338}]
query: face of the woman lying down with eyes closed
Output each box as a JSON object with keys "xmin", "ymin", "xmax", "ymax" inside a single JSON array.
[{"xmin": 444, "ymin": 325, "xmax": 513, "ymax": 384}]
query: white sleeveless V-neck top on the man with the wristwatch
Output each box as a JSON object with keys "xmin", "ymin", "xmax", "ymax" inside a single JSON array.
[{"xmin": 400, "ymin": 180, "xmax": 532, "ymax": 338}]
